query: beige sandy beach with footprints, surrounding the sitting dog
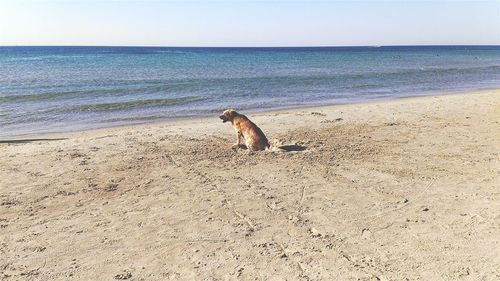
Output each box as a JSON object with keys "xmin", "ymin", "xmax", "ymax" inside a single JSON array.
[{"xmin": 0, "ymin": 90, "xmax": 500, "ymax": 280}]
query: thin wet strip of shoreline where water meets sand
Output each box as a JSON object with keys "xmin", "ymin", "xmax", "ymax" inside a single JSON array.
[{"xmin": 0, "ymin": 88, "xmax": 500, "ymax": 143}]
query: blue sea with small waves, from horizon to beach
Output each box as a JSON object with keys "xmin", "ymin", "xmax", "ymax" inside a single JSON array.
[{"xmin": 0, "ymin": 46, "xmax": 500, "ymax": 139}]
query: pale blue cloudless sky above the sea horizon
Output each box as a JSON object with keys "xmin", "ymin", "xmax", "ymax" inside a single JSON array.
[{"xmin": 0, "ymin": 0, "xmax": 500, "ymax": 47}]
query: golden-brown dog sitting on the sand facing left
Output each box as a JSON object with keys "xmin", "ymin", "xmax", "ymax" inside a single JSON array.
[{"xmin": 219, "ymin": 109, "xmax": 269, "ymax": 151}]
